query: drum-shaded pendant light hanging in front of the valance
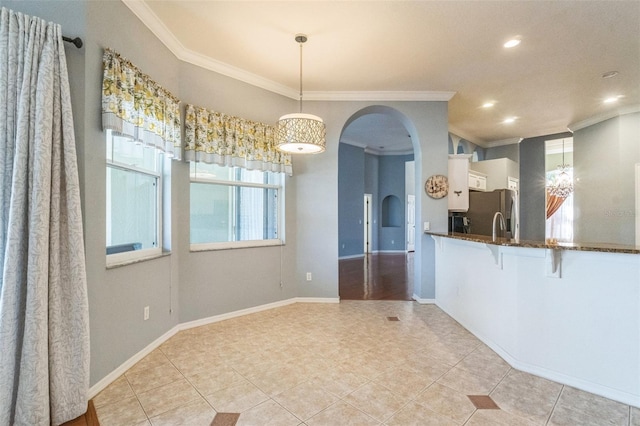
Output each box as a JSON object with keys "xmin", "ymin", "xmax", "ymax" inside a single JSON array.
[{"xmin": 276, "ymin": 34, "xmax": 326, "ymax": 154}]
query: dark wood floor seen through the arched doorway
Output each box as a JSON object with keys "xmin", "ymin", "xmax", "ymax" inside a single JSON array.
[{"xmin": 339, "ymin": 252, "xmax": 414, "ymax": 300}]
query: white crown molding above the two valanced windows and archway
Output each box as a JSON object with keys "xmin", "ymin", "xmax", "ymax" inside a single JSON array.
[{"xmin": 122, "ymin": 0, "xmax": 456, "ymax": 102}]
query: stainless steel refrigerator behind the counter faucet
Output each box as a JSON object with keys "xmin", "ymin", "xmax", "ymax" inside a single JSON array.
[{"xmin": 466, "ymin": 189, "xmax": 518, "ymax": 238}]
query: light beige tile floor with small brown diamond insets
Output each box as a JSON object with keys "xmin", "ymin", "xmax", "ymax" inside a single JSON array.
[{"xmin": 94, "ymin": 301, "xmax": 640, "ymax": 426}]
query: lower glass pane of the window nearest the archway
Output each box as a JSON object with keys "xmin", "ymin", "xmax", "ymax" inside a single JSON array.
[{"xmin": 191, "ymin": 182, "xmax": 278, "ymax": 244}]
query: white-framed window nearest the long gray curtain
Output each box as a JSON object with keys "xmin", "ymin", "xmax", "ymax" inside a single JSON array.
[{"xmin": 106, "ymin": 130, "xmax": 164, "ymax": 265}]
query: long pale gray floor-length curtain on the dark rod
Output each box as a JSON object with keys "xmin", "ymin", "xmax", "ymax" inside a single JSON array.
[{"xmin": 0, "ymin": 8, "xmax": 89, "ymax": 425}]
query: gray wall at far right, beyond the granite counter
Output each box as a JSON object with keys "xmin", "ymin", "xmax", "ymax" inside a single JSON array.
[{"xmin": 573, "ymin": 113, "xmax": 640, "ymax": 245}]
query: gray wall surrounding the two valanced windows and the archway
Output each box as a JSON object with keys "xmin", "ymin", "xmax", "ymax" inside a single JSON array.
[{"xmin": 3, "ymin": 0, "xmax": 447, "ymax": 385}]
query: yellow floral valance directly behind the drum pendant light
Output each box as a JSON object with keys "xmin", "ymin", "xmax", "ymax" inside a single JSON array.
[{"xmin": 184, "ymin": 105, "xmax": 293, "ymax": 175}]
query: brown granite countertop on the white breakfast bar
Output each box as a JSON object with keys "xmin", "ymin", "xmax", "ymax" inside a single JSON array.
[{"xmin": 425, "ymin": 232, "xmax": 640, "ymax": 254}]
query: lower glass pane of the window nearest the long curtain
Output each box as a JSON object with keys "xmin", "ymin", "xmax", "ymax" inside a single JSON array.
[{"xmin": 107, "ymin": 166, "xmax": 158, "ymax": 254}]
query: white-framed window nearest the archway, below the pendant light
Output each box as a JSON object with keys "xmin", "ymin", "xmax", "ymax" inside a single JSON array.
[{"xmin": 190, "ymin": 161, "xmax": 284, "ymax": 250}]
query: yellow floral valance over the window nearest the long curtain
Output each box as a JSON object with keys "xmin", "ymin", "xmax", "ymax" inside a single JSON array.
[{"xmin": 102, "ymin": 49, "xmax": 181, "ymax": 160}]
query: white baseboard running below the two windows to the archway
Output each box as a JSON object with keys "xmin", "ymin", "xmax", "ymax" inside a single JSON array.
[{"xmin": 89, "ymin": 297, "xmax": 340, "ymax": 399}]
